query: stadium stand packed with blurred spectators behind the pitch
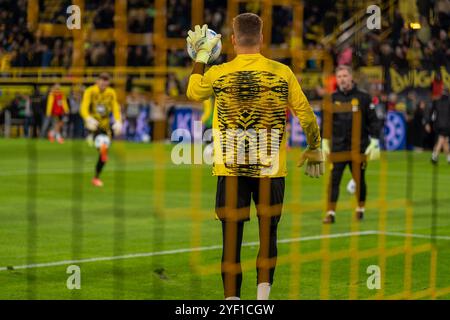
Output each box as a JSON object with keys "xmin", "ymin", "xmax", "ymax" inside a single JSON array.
[{"xmin": 0, "ymin": 0, "xmax": 450, "ymax": 147}]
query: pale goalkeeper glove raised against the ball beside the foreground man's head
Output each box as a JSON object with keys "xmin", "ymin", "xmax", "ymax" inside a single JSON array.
[{"xmin": 186, "ymin": 24, "xmax": 222, "ymax": 64}]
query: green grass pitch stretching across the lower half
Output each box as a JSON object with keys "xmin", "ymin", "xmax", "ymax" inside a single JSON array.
[{"xmin": 0, "ymin": 139, "xmax": 450, "ymax": 299}]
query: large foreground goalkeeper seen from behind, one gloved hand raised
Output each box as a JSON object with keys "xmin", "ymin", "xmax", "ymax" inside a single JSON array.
[{"xmin": 186, "ymin": 13, "xmax": 324, "ymax": 300}]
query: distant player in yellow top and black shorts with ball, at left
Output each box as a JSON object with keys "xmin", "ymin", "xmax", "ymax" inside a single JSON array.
[{"xmin": 80, "ymin": 73, "xmax": 122, "ymax": 187}]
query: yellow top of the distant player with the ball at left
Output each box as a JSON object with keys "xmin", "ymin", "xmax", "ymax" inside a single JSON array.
[{"xmin": 80, "ymin": 84, "xmax": 121, "ymax": 133}]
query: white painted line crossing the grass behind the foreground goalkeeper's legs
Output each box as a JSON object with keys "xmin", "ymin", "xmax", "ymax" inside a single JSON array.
[{"xmin": 0, "ymin": 230, "xmax": 450, "ymax": 271}]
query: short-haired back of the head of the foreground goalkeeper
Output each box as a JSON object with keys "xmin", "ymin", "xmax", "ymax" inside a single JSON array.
[{"xmin": 233, "ymin": 12, "xmax": 263, "ymax": 47}]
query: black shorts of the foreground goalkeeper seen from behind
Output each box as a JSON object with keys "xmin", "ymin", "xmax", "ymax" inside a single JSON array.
[{"xmin": 216, "ymin": 176, "xmax": 285, "ymax": 221}]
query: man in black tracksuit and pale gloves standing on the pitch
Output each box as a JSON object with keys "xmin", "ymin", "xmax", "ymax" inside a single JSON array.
[{"xmin": 322, "ymin": 65, "xmax": 381, "ymax": 223}]
